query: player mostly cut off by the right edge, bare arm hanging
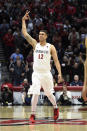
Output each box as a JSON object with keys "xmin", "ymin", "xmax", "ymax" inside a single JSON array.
[{"xmin": 82, "ymin": 37, "xmax": 87, "ymax": 102}]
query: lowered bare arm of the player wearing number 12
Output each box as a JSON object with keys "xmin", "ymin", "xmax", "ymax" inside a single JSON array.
[{"xmin": 51, "ymin": 45, "xmax": 62, "ymax": 79}]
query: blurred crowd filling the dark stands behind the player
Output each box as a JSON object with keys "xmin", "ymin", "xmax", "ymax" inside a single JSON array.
[{"xmin": 0, "ymin": 0, "xmax": 87, "ymax": 105}]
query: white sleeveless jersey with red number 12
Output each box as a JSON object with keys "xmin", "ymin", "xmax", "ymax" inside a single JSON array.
[{"xmin": 33, "ymin": 43, "xmax": 51, "ymax": 73}]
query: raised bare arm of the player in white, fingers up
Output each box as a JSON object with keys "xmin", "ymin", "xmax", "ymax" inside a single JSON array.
[{"xmin": 22, "ymin": 11, "xmax": 37, "ymax": 48}]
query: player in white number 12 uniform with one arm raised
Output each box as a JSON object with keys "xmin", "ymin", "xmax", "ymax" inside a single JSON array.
[{"xmin": 22, "ymin": 11, "xmax": 62, "ymax": 122}]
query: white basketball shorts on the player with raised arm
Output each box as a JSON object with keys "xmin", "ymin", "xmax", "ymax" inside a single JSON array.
[{"xmin": 28, "ymin": 72, "xmax": 54, "ymax": 96}]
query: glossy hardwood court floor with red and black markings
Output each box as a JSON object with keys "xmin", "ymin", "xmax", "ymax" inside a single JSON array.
[{"xmin": 0, "ymin": 106, "xmax": 87, "ymax": 131}]
